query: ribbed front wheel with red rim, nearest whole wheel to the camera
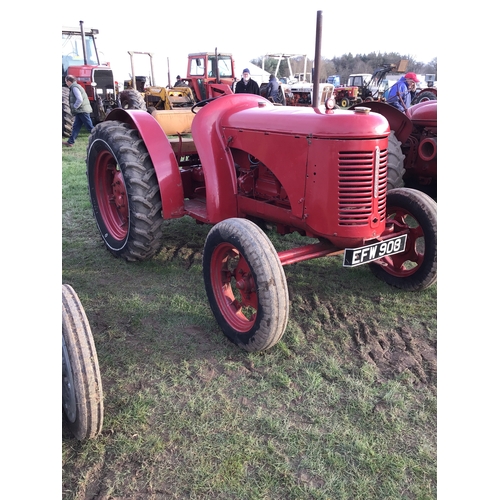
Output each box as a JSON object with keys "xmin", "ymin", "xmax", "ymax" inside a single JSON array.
[{"xmin": 203, "ymin": 218, "xmax": 289, "ymax": 351}]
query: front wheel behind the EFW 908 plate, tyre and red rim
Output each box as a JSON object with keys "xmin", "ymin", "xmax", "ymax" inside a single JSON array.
[{"xmin": 369, "ymin": 188, "xmax": 437, "ymax": 291}]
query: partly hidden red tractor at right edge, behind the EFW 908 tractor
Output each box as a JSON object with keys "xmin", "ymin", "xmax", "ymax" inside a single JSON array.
[{"xmin": 353, "ymin": 99, "xmax": 437, "ymax": 198}]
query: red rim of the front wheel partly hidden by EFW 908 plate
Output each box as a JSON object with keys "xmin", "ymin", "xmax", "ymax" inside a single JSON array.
[{"xmin": 377, "ymin": 208, "xmax": 425, "ymax": 278}]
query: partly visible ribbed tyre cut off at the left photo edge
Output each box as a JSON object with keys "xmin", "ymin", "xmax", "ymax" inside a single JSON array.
[{"xmin": 62, "ymin": 285, "xmax": 104, "ymax": 441}]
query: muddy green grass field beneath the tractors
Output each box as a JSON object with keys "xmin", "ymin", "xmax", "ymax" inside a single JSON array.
[{"xmin": 62, "ymin": 133, "xmax": 437, "ymax": 500}]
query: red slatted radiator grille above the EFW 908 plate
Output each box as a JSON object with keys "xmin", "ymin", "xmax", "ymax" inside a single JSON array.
[{"xmin": 339, "ymin": 148, "xmax": 387, "ymax": 226}]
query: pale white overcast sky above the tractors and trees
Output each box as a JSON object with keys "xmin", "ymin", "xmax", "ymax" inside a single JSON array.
[{"xmin": 60, "ymin": 5, "xmax": 438, "ymax": 85}]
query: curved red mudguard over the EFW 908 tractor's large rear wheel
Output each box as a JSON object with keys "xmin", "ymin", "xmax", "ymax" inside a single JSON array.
[{"xmin": 106, "ymin": 108, "xmax": 185, "ymax": 219}]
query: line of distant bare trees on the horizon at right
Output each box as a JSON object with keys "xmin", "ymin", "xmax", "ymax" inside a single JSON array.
[{"xmin": 251, "ymin": 52, "xmax": 438, "ymax": 85}]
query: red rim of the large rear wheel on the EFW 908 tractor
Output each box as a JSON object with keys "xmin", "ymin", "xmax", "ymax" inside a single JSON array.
[{"xmin": 94, "ymin": 151, "xmax": 129, "ymax": 240}]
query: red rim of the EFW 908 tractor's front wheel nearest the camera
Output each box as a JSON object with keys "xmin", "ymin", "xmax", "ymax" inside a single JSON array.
[{"xmin": 210, "ymin": 243, "xmax": 258, "ymax": 333}]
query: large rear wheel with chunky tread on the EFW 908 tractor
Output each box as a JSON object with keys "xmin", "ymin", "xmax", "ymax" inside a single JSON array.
[{"xmin": 87, "ymin": 121, "xmax": 163, "ymax": 261}]
